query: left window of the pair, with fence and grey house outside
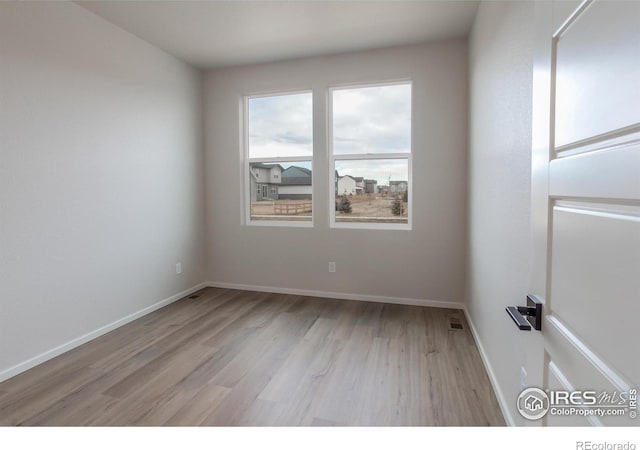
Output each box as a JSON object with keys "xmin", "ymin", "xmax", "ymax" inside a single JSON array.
[{"xmin": 245, "ymin": 92, "xmax": 313, "ymax": 226}]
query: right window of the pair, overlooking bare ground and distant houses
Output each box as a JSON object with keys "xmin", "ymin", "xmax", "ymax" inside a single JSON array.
[{"xmin": 329, "ymin": 82, "xmax": 411, "ymax": 229}]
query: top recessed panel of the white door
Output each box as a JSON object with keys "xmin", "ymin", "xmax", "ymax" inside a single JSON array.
[{"xmin": 555, "ymin": 1, "xmax": 640, "ymax": 147}]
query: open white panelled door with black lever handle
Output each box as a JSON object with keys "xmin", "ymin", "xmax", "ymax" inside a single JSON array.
[{"xmin": 530, "ymin": 1, "xmax": 640, "ymax": 426}]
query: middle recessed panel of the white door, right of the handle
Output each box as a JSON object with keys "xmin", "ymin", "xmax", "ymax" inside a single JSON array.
[{"xmin": 550, "ymin": 202, "xmax": 640, "ymax": 380}]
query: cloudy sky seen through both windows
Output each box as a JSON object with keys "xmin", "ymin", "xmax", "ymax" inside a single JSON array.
[{"xmin": 249, "ymin": 84, "xmax": 411, "ymax": 184}]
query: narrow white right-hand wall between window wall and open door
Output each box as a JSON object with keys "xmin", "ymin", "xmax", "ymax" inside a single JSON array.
[{"xmin": 466, "ymin": 2, "xmax": 533, "ymax": 423}]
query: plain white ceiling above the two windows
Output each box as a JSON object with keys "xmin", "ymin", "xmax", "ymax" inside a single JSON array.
[{"xmin": 76, "ymin": 0, "xmax": 478, "ymax": 68}]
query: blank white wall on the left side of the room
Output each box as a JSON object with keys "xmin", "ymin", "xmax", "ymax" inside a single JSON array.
[{"xmin": 0, "ymin": 2, "xmax": 204, "ymax": 379}]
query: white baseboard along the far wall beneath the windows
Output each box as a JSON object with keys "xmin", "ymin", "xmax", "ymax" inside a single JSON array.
[{"xmin": 208, "ymin": 281, "xmax": 464, "ymax": 309}]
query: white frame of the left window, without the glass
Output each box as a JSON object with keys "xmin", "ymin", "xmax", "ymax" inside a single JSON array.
[{"xmin": 240, "ymin": 89, "xmax": 316, "ymax": 228}]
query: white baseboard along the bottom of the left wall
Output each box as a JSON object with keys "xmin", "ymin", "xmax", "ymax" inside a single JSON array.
[{"xmin": 0, "ymin": 283, "xmax": 208, "ymax": 382}]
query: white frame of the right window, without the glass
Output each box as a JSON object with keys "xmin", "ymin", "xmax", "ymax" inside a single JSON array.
[{"xmin": 327, "ymin": 79, "xmax": 415, "ymax": 231}]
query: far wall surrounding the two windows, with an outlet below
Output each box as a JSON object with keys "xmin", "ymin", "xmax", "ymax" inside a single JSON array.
[{"xmin": 205, "ymin": 40, "xmax": 468, "ymax": 304}]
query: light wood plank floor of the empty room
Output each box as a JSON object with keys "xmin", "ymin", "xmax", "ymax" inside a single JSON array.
[{"xmin": 0, "ymin": 288, "xmax": 504, "ymax": 426}]
